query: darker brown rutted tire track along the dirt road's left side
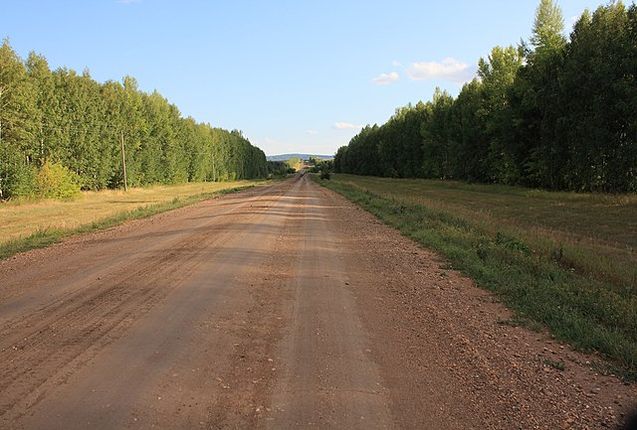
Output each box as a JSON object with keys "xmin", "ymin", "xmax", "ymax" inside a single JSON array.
[{"xmin": 0, "ymin": 181, "xmax": 288, "ymax": 418}]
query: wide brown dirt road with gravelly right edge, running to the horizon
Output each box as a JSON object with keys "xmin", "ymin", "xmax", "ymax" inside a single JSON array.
[{"xmin": 0, "ymin": 178, "xmax": 637, "ymax": 429}]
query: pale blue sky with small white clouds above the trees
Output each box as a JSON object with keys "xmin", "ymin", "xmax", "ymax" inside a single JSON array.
[{"xmin": 0, "ymin": 0, "xmax": 601, "ymax": 154}]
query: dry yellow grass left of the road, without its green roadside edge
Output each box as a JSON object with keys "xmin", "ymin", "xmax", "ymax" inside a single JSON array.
[{"xmin": 0, "ymin": 181, "xmax": 257, "ymax": 245}]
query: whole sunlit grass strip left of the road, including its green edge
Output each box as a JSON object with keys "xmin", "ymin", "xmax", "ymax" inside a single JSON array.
[{"xmin": 0, "ymin": 181, "xmax": 263, "ymax": 259}]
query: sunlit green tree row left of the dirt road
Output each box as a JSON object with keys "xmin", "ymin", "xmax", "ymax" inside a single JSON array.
[{"xmin": 0, "ymin": 41, "xmax": 267, "ymax": 199}]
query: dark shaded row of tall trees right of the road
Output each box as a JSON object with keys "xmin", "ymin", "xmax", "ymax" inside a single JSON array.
[{"xmin": 335, "ymin": 0, "xmax": 637, "ymax": 192}]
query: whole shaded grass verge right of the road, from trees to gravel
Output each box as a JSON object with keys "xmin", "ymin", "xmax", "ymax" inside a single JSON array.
[{"xmin": 321, "ymin": 175, "xmax": 637, "ymax": 381}]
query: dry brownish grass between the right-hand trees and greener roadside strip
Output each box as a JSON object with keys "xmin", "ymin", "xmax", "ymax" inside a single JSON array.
[{"xmin": 338, "ymin": 175, "xmax": 637, "ymax": 290}]
